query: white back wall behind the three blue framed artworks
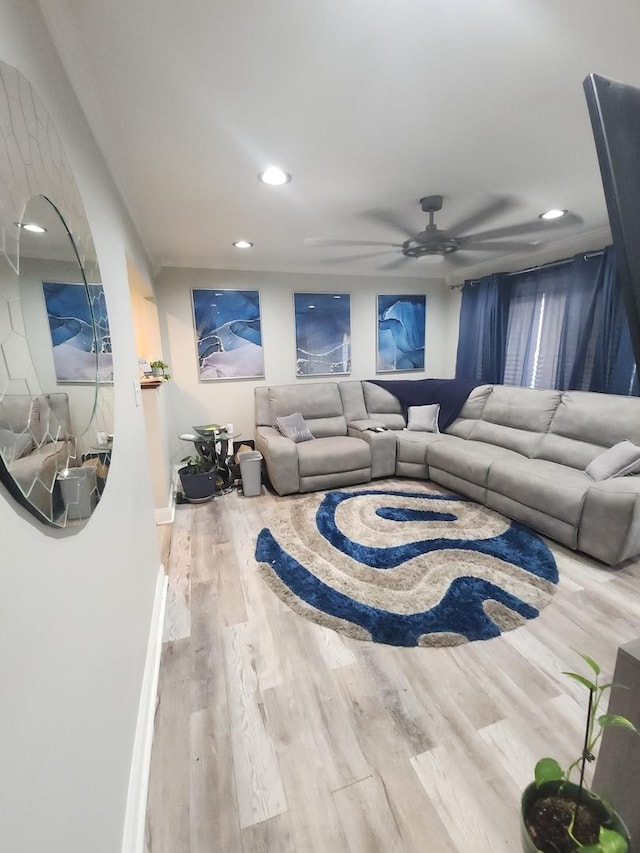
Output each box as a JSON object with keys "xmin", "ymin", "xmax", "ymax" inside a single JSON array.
[{"xmin": 155, "ymin": 268, "xmax": 460, "ymax": 458}]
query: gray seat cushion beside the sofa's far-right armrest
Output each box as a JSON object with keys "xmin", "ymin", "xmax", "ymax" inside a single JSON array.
[{"xmin": 487, "ymin": 458, "xmax": 593, "ymax": 527}]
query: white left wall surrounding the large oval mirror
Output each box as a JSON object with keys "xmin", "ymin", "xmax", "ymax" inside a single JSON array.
[{"xmin": 0, "ymin": 0, "xmax": 159, "ymax": 853}]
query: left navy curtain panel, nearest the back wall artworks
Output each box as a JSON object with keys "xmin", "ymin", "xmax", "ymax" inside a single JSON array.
[{"xmin": 456, "ymin": 273, "xmax": 509, "ymax": 383}]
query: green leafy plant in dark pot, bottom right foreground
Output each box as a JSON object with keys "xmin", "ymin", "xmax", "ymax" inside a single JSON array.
[{"xmin": 521, "ymin": 652, "xmax": 637, "ymax": 853}]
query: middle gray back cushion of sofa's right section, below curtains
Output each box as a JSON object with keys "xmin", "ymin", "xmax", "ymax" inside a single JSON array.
[{"xmin": 469, "ymin": 385, "xmax": 562, "ymax": 457}]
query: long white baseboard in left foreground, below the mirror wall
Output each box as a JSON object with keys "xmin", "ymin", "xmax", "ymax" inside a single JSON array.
[{"xmin": 122, "ymin": 565, "xmax": 167, "ymax": 853}]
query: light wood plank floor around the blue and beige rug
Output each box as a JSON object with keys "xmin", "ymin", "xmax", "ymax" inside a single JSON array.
[{"xmin": 146, "ymin": 481, "xmax": 640, "ymax": 853}]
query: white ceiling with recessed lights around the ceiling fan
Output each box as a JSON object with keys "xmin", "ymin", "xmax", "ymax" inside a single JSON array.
[{"xmin": 41, "ymin": 0, "xmax": 640, "ymax": 282}]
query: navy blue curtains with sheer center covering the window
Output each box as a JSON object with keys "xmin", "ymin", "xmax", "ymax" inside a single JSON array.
[{"xmin": 456, "ymin": 246, "xmax": 640, "ymax": 395}]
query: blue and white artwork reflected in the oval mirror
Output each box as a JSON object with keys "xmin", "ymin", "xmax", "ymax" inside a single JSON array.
[{"xmin": 42, "ymin": 281, "xmax": 113, "ymax": 384}]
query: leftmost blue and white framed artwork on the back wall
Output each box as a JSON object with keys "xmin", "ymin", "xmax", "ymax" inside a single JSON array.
[{"xmin": 191, "ymin": 289, "xmax": 264, "ymax": 381}]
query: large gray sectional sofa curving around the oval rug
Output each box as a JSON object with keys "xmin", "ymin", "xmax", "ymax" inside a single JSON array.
[{"xmin": 255, "ymin": 380, "xmax": 640, "ymax": 565}]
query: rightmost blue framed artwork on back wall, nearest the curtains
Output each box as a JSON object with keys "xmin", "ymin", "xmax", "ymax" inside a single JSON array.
[{"xmin": 376, "ymin": 294, "xmax": 427, "ymax": 373}]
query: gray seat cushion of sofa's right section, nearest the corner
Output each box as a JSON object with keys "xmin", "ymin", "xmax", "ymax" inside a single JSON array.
[{"xmin": 427, "ymin": 435, "xmax": 525, "ymax": 487}]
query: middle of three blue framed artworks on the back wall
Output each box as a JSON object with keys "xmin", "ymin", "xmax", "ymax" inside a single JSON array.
[{"xmin": 293, "ymin": 293, "xmax": 351, "ymax": 376}]
